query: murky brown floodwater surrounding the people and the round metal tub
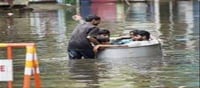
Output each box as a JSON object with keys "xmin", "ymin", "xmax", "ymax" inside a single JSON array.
[{"xmin": 0, "ymin": 0, "xmax": 199, "ymax": 88}]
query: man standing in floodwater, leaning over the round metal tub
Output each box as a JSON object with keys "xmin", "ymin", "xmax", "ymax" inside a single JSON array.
[{"xmin": 68, "ymin": 15, "xmax": 101, "ymax": 59}]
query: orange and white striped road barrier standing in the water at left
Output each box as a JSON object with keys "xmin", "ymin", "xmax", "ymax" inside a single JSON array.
[{"xmin": 0, "ymin": 43, "xmax": 41, "ymax": 88}]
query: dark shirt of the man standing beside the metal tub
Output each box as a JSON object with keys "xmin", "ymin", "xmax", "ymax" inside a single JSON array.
[{"xmin": 68, "ymin": 22, "xmax": 99, "ymax": 50}]
